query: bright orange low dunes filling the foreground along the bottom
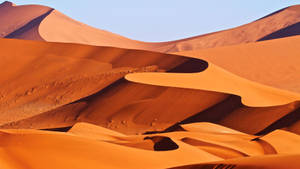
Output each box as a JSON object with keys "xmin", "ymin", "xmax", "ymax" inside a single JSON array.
[{"xmin": 0, "ymin": 123, "xmax": 300, "ymax": 169}]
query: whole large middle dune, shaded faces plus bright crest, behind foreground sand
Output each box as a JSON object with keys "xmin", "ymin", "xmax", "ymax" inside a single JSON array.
[{"xmin": 0, "ymin": 36, "xmax": 299, "ymax": 134}]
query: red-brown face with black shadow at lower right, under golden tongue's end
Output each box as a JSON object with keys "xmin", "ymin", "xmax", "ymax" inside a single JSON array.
[{"xmin": 165, "ymin": 101, "xmax": 299, "ymax": 135}]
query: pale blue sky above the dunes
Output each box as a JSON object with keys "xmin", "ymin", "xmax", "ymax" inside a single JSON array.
[{"xmin": 7, "ymin": 0, "xmax": 300, "ymax": 41}]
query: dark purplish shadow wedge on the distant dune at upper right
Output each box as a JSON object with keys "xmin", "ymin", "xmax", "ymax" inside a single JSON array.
[{"xmin": 258, "ymin": 22, "xmax": 300, "ymax": 41}]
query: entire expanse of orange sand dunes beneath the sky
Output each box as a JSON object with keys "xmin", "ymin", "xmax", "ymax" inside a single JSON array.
[{"xmin": 0, "ymin": 1, "xmax": 300, "ymax": 169}]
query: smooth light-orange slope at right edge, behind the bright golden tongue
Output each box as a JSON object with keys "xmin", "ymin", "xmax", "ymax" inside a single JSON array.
[{"xmin": 177, "ymin": 36, "xmax": 300, "ymax": 93}]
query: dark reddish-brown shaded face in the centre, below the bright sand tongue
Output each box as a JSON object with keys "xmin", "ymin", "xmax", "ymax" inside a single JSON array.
[{"xmin": 3, "ymin": 80, "xmax": 226, "ymax": 133}]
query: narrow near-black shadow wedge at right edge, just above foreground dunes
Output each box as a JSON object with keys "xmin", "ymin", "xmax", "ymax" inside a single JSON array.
[{"xmin": 255, "ymin": 108, "xmax": 300, "ymax": 136}]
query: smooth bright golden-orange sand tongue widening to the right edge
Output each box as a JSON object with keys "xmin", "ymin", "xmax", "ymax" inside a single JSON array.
[{"xmin": 125, "ymin": 64, "xmax": 300, "ymax": 107}]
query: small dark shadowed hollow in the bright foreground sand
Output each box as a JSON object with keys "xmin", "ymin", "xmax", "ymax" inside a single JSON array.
[{"xmin": 144, "ymin": 136, "xmax": 179, "ymax": 151}]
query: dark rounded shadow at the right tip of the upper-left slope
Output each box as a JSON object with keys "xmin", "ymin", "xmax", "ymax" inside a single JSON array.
[{"xmin": 168, "ymin": 58, "xmax": 208, "ymax": 73}]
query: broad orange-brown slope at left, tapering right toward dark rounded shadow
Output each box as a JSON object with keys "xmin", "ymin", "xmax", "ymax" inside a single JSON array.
[{"xmin": 0, "ymin": 39, "xmax": 193, "ymax": 128}]
